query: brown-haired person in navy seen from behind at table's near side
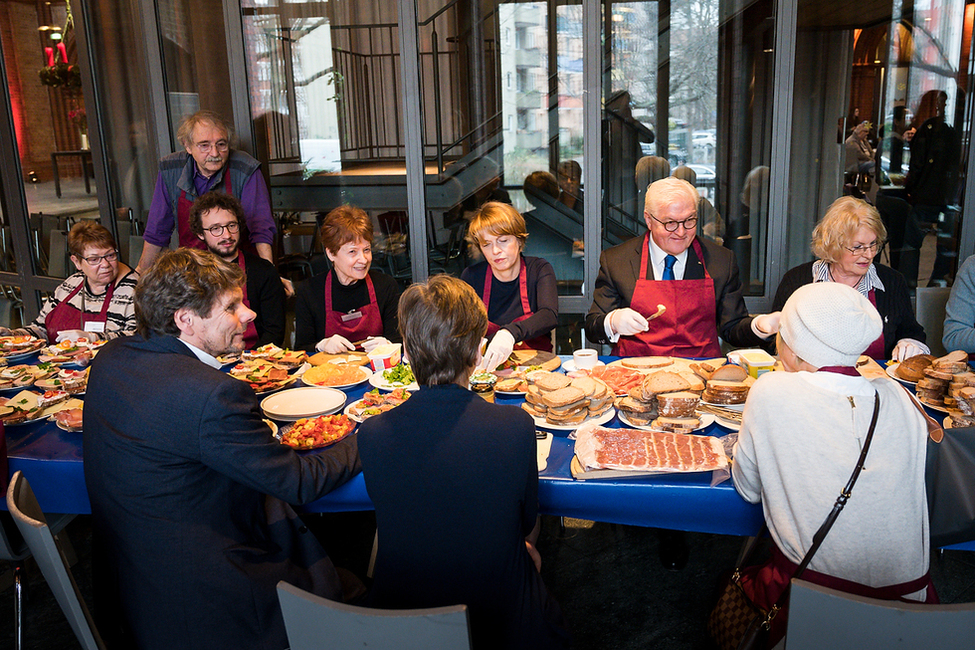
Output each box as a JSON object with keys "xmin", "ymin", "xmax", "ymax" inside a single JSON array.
[{"xmin": 357, "ymin": 275, "xmax": 568, "ymax": 650}]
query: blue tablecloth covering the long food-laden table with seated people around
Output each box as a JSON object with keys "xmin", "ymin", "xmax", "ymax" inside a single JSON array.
[{"xmin": 0, "ymin": 357, "xmax": 969, "ymax": 547}]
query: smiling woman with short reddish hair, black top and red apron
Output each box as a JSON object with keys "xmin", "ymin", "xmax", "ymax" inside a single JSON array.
[{"xmin": 295, "ymin": 205, "xmax": 400, "ymax": 354}]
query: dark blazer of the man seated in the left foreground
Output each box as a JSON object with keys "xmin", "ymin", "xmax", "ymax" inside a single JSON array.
[{"xmin": 84, "ymin": 336, "xmax": 360, "ymax": 650}]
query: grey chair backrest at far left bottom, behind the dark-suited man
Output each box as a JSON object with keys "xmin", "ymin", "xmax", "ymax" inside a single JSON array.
[{"xmin": 7, "ymin": 471, "xmax": 105, "ymax": 650}]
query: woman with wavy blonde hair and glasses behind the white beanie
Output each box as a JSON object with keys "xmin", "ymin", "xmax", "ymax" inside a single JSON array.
[{"xmin": 772, "ymin": 196, "xmax": 930, "ymax": 361}]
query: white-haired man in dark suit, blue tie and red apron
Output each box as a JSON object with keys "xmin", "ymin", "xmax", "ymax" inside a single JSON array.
[{"xmin": 586, "ymin": 177, "xmax": 778, "ymax": 358}]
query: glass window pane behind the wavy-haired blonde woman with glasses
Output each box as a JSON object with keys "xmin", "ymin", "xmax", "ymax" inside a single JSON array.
[{"xmin": 787, "ymin": 0, "xmax": 973, "ymax": 286}]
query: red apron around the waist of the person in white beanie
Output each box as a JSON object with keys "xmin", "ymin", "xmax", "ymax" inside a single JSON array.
[{"xmin": 741, "ymin": 544, "xmax": 940, "ymax": 648}]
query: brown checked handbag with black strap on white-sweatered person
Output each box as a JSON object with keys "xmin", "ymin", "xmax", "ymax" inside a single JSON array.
[{"xmin": 708, "ymin": 393, "xmax": 880, "ymax": 650}]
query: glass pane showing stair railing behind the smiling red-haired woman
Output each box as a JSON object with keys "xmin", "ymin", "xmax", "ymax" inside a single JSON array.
[{"xmin": 248, "ymin": 0, "xmax": 412, "ymax": 283}]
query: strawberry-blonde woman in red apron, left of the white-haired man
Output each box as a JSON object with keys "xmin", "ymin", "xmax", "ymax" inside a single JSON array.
[{"xmin": 460, "ymin": 201, "xmax": 559, "ymax": 370}]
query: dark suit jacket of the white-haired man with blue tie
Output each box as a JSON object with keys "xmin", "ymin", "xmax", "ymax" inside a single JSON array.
[{"xmin": 586, "ymin": 235, "xmax": 762, "ymax": 347}]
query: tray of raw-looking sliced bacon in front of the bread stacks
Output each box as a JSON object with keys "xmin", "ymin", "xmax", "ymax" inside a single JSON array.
[{"xmin": 571, "ymin": 425, "xmax": 728, "ymax": 480}]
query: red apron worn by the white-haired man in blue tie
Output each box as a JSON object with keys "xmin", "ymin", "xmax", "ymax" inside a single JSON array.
[{"xmin": 613, "ymin": 232, "xmax": 721, "ymax": 358}]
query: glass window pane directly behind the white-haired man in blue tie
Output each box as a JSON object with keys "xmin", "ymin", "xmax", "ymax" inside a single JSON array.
[{"xmin": 600, "ymin": 0, "xmax": 774, "ymax": 295}]
